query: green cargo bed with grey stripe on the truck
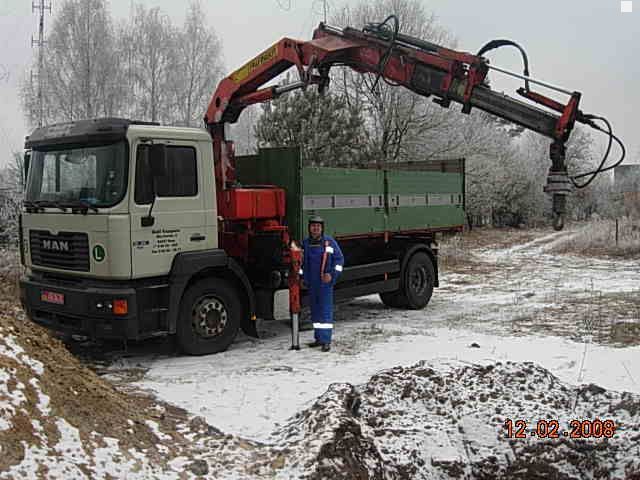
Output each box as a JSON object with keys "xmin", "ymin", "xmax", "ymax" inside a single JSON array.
[{"xmin": 236, "ymin": 148, "xmax": 464, "ymax": 240}]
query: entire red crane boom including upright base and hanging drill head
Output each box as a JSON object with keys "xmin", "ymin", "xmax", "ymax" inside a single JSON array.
[{"xmin": 204, "ymin": 16, "xmax": 616, "ymax": 229}]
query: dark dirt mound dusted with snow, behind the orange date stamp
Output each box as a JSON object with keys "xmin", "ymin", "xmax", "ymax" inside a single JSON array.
[{"xmin": 274, "ymin": 363, "xmax": 640, "ymax": 480}]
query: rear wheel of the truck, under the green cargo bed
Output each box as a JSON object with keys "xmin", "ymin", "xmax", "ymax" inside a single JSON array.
[{"xmin": 398, "ymin": 252, "xmax": 436, "ymax": 310}]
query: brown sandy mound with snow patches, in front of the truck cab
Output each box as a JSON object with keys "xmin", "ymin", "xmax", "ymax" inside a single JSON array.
[{"xmin": 0, "ymin": 302, "xmax": 222, "ymax": 478}]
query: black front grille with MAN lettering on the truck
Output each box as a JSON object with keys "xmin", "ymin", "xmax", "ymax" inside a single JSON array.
[{"xmin": 29, "ymin": 230, "xmax": 89, "ymax": 272}]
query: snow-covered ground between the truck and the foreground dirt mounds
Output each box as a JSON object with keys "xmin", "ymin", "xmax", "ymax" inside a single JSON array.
[{"xmin": 113, "ymin": 227, "xmax": 640, "ymax": 442}]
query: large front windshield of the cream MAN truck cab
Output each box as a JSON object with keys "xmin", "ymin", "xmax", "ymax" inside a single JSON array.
[{"xmin": 25, "ymin": 142, "xmax": 128, "ymax": 207}]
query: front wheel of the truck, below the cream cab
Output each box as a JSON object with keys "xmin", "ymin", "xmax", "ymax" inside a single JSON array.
[{"xmin": 176, "ymin": 277, "xmax": 242, "ymax": 355}]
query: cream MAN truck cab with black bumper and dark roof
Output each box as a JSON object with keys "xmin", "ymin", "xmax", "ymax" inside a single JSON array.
[{"xmin": 20, "ymin": 118, "xmax": 255, "ymax": 350}]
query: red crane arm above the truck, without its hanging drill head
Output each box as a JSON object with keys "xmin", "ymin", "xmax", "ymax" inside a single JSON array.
[{"xmin": 205, "ymin": 24, "xmax": 580, "ymax": 140}]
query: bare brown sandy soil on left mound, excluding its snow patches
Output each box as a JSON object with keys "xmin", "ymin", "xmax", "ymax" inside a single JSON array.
[{"xmin": 0, "ymin": 300, "xmax": 208, "ymax": 472}]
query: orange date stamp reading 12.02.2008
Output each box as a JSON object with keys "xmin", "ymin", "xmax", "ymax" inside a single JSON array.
[{"xmin": 503, "ymin": 418, "xmax": 616, "ymax": 439}]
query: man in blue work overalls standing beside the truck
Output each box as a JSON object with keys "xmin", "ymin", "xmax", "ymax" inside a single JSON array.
[{"xmin": 302, "ymin": 215, "xmax": 344, "ymax": 352}]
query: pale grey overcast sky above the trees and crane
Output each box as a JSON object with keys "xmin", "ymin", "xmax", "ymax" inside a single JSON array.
[{"xmin": 0, "ymin": 0, "xmax": 640, "ymax": 170}]
